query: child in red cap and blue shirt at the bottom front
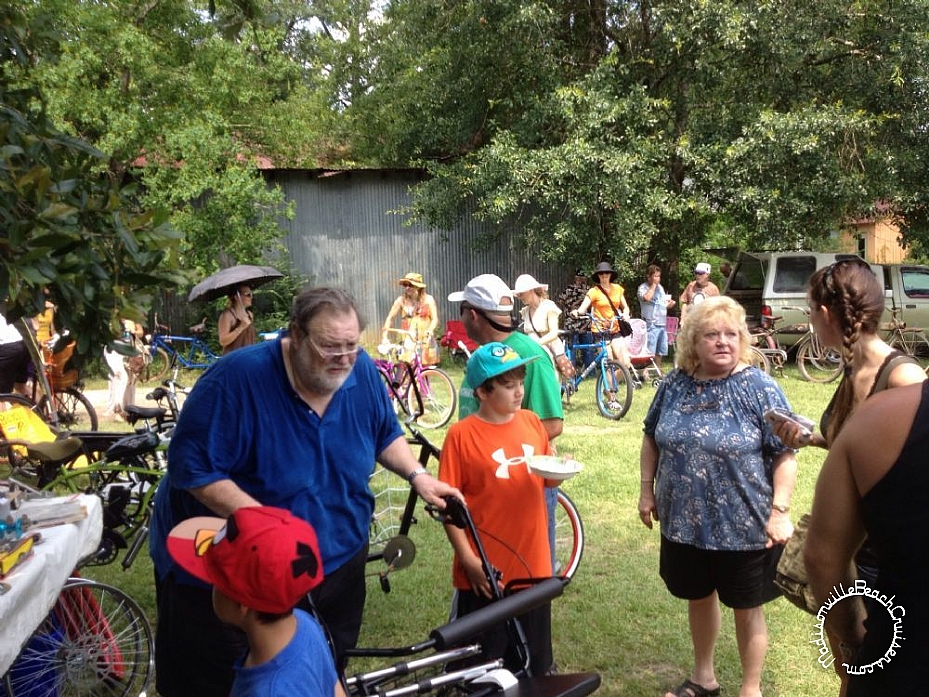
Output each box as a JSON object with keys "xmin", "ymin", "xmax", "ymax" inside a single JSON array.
[{"xmin": 168, "ymin": 506, "xmax": 345, "ymax": 697}]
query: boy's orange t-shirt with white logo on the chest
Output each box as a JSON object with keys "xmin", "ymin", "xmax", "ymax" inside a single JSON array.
[{"xmin": 439, "ymin": 409, "xmax": 552, "ymax": 590}]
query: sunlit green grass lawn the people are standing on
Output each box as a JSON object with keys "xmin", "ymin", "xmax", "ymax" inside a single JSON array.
[{"xmin": 85, "ymin": 356, "xmax": 838, "ymax": 697}]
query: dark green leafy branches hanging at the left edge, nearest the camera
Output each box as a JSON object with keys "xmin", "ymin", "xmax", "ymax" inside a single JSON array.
[{"xmin": 0, "ymin": 5, "xmax": 183, "ymax": 356}]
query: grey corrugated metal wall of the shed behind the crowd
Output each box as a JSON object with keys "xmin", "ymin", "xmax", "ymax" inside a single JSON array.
[{"xmin": 265, "ymin": 170, "xmax": 573, "ymax": 341}]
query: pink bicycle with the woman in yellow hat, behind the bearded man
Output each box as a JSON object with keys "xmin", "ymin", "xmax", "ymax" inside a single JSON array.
[{"xmin": 372, "ymin": 329, "xmax": 458, "ymax": 428}]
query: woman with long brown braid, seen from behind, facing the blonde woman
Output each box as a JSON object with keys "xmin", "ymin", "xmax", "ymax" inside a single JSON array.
[{"xmin": 774, "ymin": 258, "xmax": 926, "ymax": 696}]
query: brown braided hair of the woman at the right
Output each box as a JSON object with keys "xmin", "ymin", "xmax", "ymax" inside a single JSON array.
[{"xmin": 810, "ymin": 259, "xmax": 884, "ymax": 445}]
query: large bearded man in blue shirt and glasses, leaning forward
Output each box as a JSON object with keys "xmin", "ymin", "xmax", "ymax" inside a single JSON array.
[{"xmin": 151, "ymin": 288, "xmax": 460, "ymax": 697}]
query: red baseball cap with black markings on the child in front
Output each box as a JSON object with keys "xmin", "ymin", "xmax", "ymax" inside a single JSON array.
[{"xmin": 168, "ymin": 506, "xmax": 323, "ymax": 614}]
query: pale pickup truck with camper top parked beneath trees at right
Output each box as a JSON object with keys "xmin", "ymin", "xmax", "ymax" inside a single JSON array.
[{"xmin": 723, "ymin": 252, "xmax": 929, "ymax": 348}]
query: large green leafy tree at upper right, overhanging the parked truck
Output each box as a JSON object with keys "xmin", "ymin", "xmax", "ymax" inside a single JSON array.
[{"xmin": 353, "ymin": 0, "xmax": 929, "ymax": 284}]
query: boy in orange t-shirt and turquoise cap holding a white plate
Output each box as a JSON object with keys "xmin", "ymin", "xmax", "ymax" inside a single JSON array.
[{"xmin": 439, "ymin": 342, "xmax": 557, "ymax": 675}]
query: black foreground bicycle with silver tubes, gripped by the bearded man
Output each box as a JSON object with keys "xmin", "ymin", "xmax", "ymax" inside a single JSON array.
[{"xmin": 345, "ymin": 497, "xmax": 600, "ymax": 697}]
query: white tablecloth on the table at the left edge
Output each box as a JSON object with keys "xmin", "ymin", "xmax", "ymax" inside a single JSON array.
[{"xmin": 0, "ymin": 494, "xmax": 103, "ymax": 675}]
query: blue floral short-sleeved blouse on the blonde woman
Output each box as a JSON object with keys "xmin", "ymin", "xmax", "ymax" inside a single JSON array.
[{"xmin": 645, "ymin": 367, "xmax": 790, "ymax": 550}]
